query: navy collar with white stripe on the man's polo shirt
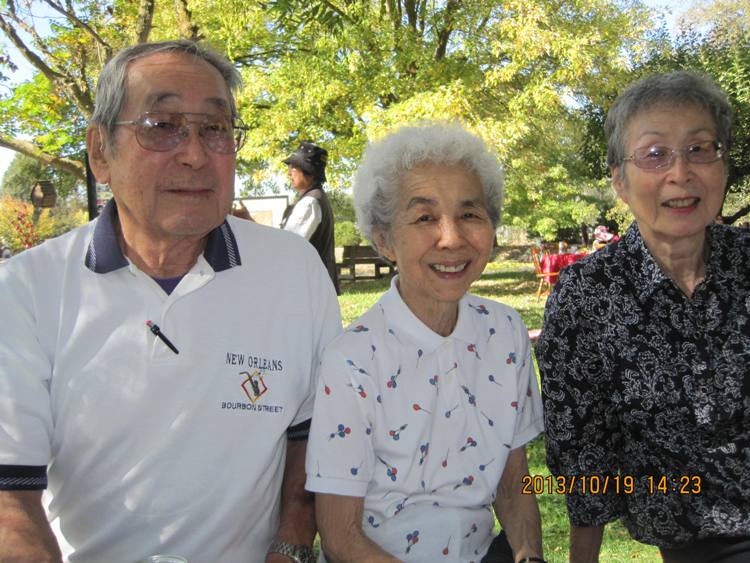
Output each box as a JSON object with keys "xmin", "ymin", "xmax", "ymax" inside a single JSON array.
[{"xmin": 85, "ymin": 199, "xmax": 242, "ymax": 274}]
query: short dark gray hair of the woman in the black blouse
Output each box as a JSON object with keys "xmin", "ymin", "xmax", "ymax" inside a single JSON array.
[{"xmin": 604, "ymin": 71, "xmax": 733, "ymax": 170}]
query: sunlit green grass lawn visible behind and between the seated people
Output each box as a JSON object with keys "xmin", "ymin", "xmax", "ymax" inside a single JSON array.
[{"xmin": 339, "ymin": 262, "xmax": 661, "ymax": 563}]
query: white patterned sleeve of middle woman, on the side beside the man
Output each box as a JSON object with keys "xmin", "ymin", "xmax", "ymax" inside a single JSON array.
[{"xmin": 305, "ymin": 344, "xmax": 377, "ymax": 497}]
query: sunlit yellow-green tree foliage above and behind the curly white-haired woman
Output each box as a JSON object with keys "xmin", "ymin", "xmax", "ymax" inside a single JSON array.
[{"xmin": 232, "ymin": 0, "xmax": 648, "ymax": 236}]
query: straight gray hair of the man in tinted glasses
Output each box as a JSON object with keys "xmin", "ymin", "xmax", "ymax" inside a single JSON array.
[{"xmin": 91, "ymin": 39, "xmax": 242, "ymax": 145}]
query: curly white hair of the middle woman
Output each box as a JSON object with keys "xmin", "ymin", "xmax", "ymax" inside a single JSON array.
[{"xmin": 353, "ymin": 122, "xmax": 503, "ymax": 246}]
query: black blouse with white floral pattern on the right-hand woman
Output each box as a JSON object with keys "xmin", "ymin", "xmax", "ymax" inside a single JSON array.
[{"xmin": 537, "ymin": 224, "xmax": 750, "ymax": 547}]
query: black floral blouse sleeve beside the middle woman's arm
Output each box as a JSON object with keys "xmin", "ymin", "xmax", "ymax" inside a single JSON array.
[{"xmin": 537, "ymin": 270, "xmax": 625, "ymax": 527}]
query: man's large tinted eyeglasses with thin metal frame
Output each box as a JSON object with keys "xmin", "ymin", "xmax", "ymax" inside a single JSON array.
[{"xmin": 115, "ymin": 111, "xmax": 247, "ymax": 154}]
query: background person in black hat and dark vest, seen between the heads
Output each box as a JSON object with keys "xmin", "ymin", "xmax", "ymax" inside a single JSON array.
[{"xmin": 280, "ymin": 141, "xmax": 341, "ymax": 295}]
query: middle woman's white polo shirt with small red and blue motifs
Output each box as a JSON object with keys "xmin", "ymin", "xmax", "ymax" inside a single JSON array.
[{"xmin": 306, "ymin": 277, "xmax": 543, "ymax": 562}]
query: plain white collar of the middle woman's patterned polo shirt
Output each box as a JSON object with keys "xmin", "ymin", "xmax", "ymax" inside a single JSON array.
[{"xmin": 380, "ymin": 275, "xmax": 475, "ymax": 354}]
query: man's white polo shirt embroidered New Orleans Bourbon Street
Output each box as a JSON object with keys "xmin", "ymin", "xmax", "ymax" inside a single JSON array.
[{"xmin": 0, "ymin": 206, "xmax": 341, "ymax": 563}]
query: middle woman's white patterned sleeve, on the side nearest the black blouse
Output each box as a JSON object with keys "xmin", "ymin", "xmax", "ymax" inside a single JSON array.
[{"xmin": 510, "ymin": 311, "xmax": 544, "ymax": 448}]
